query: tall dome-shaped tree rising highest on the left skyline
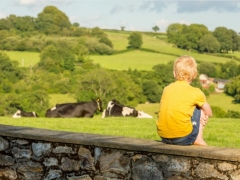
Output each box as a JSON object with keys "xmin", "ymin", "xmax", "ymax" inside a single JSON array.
[{"xmin": 36, "ymin": 6, "xmax": 71, "ymax": 34}]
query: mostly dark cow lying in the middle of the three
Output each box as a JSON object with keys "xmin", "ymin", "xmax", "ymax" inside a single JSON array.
[{"xmin": 45, "ymin": 98, "xmax": 102, "ymax": 118}]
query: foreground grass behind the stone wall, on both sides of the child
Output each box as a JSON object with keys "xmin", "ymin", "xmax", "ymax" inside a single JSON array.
[{"xmin": 0, "ymin": 115, "xmax": 240, "ymax": 148}]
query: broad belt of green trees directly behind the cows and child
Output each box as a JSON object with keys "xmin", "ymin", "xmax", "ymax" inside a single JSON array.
[{"xmin": 0, "ymin": 46, "xmax": 240, "ymax": 116}]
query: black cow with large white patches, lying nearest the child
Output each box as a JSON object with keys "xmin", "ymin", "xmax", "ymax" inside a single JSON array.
[{"xmin": 102, "ymin": 100, "xmax": 153, "ymax": 118}]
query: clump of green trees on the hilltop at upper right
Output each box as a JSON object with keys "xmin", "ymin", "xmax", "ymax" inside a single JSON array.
[{"xmin": 167, "ymin": 23, "xmax": 240, "ymax": 53}]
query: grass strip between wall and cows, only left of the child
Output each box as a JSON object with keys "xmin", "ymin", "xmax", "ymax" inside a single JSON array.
[{"xmin": 0, "ymin": 115, "xmax": 159, "ymax": 140}]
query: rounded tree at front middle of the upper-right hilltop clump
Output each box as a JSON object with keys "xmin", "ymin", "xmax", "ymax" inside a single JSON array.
[{"xmin": 199, "ymin": 34, "xmax": 220, "ymax": 53}]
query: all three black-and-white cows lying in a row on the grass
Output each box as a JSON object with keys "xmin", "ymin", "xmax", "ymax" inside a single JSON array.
[{"xmin": 12, "ymin": 98, "xmax": 153, "ymax": 118}]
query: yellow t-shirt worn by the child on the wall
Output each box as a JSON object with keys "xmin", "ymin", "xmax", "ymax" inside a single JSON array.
[{"xmin": 157, "ymin": 81, "xmax": 206, "ymax": 138}]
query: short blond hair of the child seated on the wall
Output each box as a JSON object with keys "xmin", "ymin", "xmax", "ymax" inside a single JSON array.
[{"xmin": 173, "ymin": 56, "xmax": 198, "ymax": 81}]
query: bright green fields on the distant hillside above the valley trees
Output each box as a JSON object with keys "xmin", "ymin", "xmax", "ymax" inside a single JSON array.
[{"xmin": 2, "ymin": 31, "xmax": 240, "ymax": 70}]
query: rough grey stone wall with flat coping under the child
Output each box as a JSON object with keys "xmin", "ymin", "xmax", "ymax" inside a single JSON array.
[{"xmin": 0, "ymin": 125, "xmax": 240, "ymax": 180}]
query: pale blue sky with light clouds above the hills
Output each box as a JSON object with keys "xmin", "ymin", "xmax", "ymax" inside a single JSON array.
[{"xmin": 0, "ymin": 0, "xmax": 240, "ymax": 33}]
